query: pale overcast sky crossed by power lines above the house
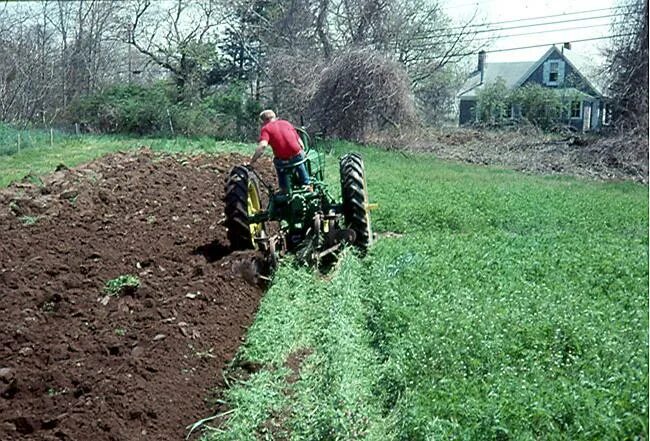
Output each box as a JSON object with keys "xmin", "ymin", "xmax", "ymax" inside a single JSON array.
[{"xmin": 443, "ymin": 0, "xmax": 620, "ymax": 63}]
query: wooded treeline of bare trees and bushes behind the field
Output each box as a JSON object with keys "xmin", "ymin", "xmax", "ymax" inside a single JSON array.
[{"xmin": 0, "ymin": 0, "xmax": 647, "ymax": 140}]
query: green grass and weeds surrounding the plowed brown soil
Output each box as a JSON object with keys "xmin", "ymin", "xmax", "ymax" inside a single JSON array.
[{"xmin": 0, "ymin": 132, "xmax": 648, "ymax": 440}]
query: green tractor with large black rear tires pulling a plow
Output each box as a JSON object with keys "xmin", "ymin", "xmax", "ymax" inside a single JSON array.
[{"xmin": 224, "ymin": 129, "xmax": 373, "ymax": 267}]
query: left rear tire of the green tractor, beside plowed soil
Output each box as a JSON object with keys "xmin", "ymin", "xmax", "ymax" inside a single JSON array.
[{"xmin": 224, "ymin": 165, "xmax": 260, "ymax": 250}]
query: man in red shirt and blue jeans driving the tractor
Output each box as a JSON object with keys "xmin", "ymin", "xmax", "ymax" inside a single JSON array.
[{"xmin": 250, "ymin": 110, "xmax": 310, "ymax": 192}]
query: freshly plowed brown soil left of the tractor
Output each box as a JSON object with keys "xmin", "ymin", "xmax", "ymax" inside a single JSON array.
[{"xmin": 0, "ymin": 150, "xmax": 273, "ymax": 440}]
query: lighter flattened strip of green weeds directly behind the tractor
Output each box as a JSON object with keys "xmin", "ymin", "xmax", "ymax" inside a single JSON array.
[{"xmin": 210, "ymin": 254, "xmax": 385, "ymax": 440}]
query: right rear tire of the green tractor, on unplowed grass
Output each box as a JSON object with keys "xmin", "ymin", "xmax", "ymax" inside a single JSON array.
[{"xmin": 339, "ymin": 153, "xmax": 372, "ymax": 251}]
